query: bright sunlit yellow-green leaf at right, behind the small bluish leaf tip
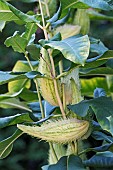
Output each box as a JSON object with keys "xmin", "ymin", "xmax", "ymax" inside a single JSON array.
[{"xmin": 81, "ymin": 77, "xmax": 109, "ymax": 96}]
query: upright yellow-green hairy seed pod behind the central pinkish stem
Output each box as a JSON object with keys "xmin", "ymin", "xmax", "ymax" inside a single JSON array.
[{"xmin": 38, "ymin": 48, "xmax": 62, "ymax": 106}]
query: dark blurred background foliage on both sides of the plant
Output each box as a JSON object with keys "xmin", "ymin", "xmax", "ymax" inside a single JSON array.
[{"xmin": 0, "ymin": 2, "xmax": 113, "ymax": 170}]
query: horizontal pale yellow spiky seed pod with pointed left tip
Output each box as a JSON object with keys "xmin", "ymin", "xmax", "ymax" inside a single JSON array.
[{"xmin": 18, "ymin": 118, "xmax": 89, "ymax": 144}]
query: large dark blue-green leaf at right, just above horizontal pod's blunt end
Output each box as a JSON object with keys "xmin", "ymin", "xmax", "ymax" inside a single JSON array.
[{"xmin": 69, "ymin": 97, "xmax": 113, "ymax": 134}]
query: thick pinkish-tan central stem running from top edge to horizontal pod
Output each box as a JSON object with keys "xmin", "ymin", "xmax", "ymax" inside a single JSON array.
[{"xmin": 39, "ymin": 0, "xmax": 66, "ymax": 119}]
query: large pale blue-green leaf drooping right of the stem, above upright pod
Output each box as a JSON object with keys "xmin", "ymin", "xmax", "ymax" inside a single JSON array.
[{"xmin": 42, "ymin": 35, "xmax": 90, "ymax": 65}]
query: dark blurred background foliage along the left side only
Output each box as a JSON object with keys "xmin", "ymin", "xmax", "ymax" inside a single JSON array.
[{"xmin": 0, "ymin": 2, "xmax": 48, "ymax": 170}]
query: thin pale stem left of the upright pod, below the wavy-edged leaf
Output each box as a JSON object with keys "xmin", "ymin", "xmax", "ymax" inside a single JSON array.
[{"xmin": 25, "ymin": 52, "xmax": 45, "ymax": 118}]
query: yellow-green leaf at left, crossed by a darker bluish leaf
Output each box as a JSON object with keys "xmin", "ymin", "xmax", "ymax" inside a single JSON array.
[{"xmin": 8, "ymin": 60, "xmax": 31, "ymax": 93}]
